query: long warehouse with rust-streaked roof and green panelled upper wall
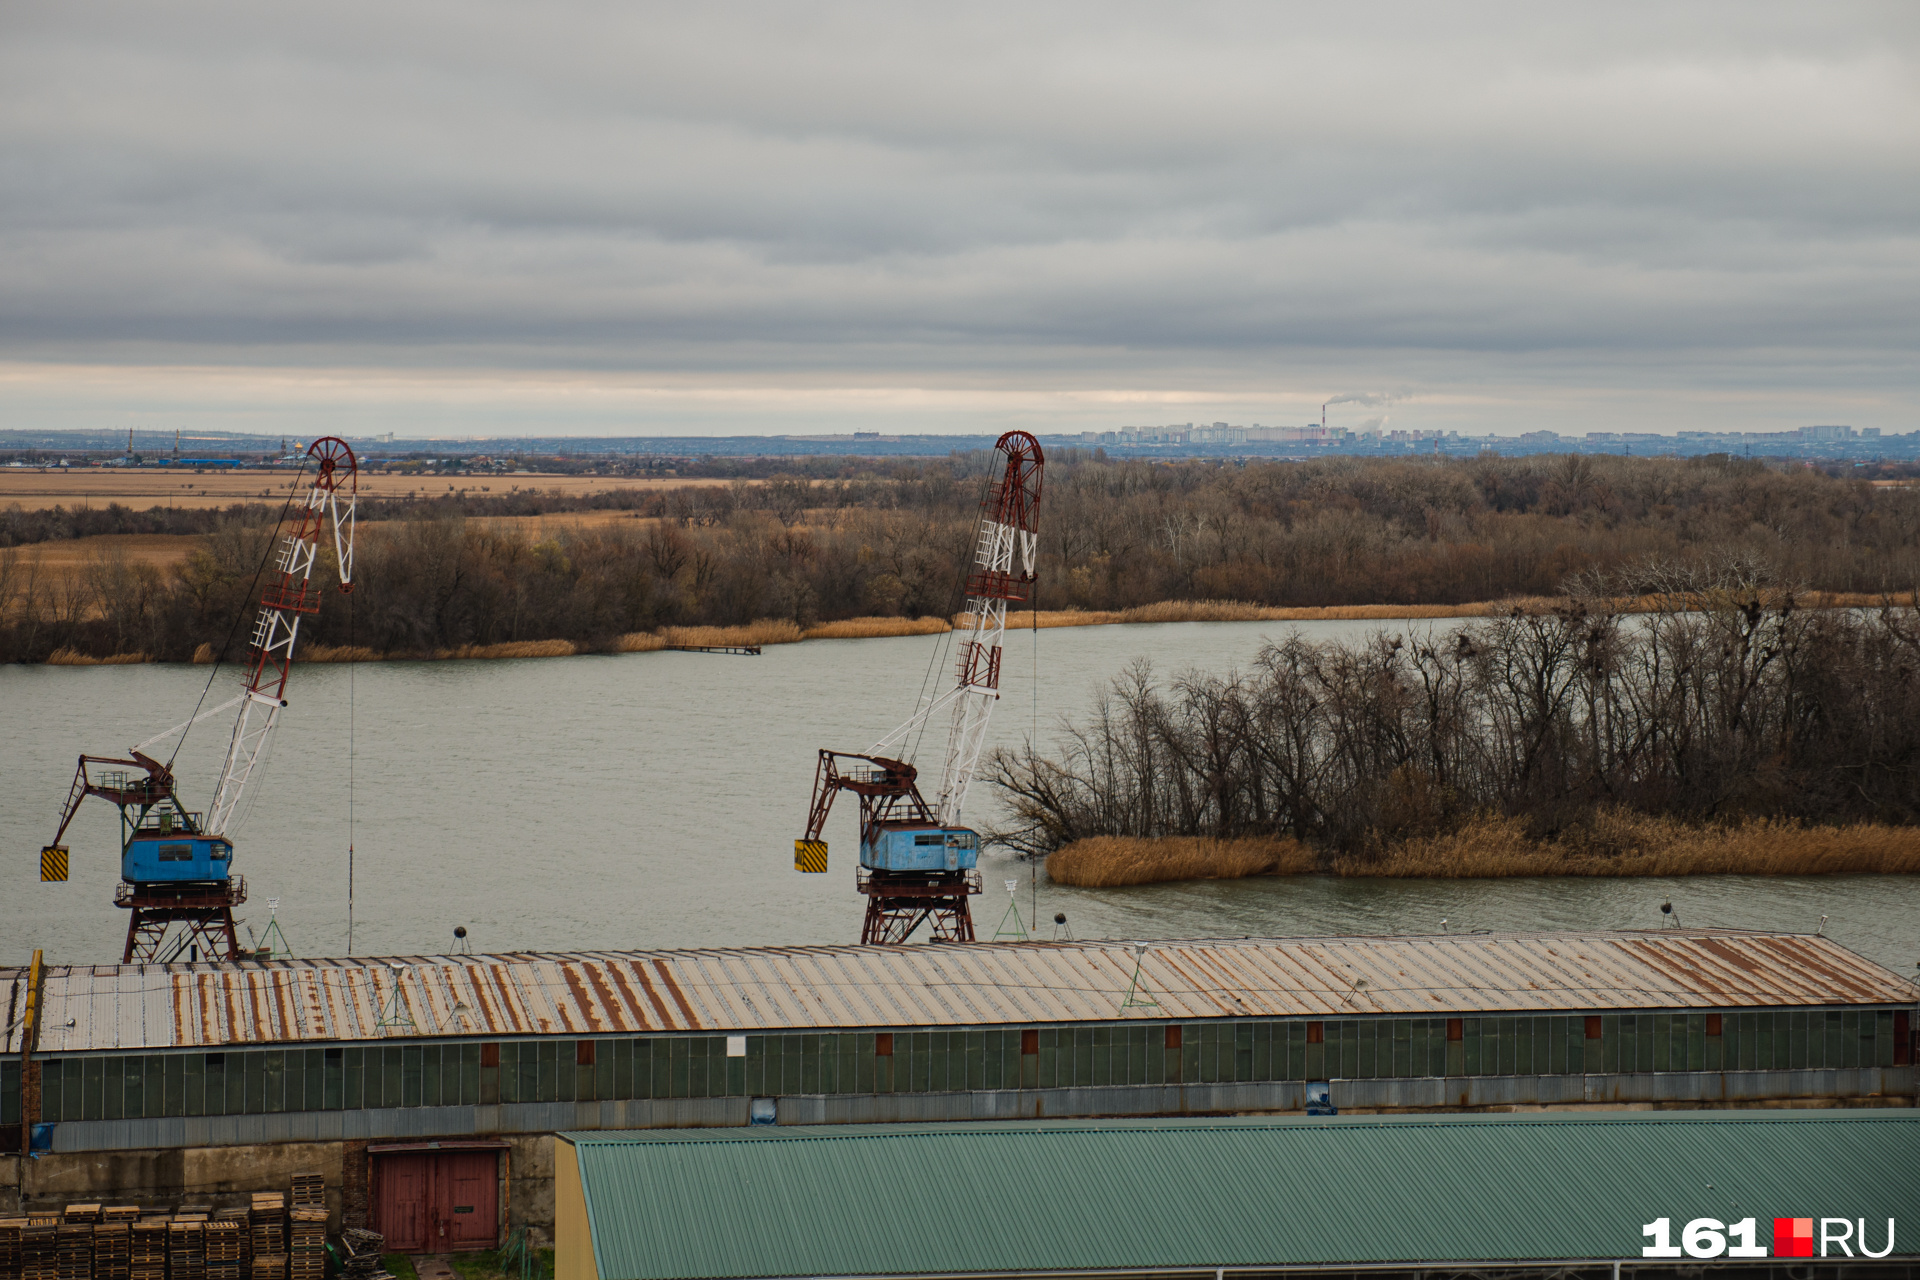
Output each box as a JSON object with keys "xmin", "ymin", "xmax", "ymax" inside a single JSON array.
[{"xmin": 0, "ymin": 929, "xmax": 1916, "ymax": 1247}]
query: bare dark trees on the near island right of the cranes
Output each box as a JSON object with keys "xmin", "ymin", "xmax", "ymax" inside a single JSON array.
[{"xmin": 991, "ymin": 562, "xmax": 1920, "ymax": 862}]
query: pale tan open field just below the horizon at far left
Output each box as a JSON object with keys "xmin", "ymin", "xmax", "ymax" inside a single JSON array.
[{"xmin": 0, "ymin": 466, "xmax": 732, "ymax": 510}]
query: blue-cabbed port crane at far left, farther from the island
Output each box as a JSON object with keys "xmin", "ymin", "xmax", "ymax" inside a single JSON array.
[{"xmin": 40, "ymin": 436, "xmax": 359, "ymax": 963}]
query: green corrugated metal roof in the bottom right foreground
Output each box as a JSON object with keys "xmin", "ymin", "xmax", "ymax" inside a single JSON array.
[{"xmin": 563, "ymin": 1109, "xmax": 1920, "ymax": 1280}]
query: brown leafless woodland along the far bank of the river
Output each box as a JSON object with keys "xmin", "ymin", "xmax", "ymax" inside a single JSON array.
[{"xmin": 11, "ymin": 451, "xmax": 1920, "ymax": 662}]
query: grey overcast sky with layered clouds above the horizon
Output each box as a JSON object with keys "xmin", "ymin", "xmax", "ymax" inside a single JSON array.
[{"xmin": 0, "ymin": 0, "xmax": 1920, "ymax": 436}]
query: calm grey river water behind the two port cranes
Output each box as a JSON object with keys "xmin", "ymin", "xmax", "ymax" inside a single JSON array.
[{"xmin": 0, "ymin": 622, "xmax": 1920, "ymax": 973}]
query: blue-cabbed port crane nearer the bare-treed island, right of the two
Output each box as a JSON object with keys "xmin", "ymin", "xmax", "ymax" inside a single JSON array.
[{"xmin": 793, "ymin": 432, "xmax": 1044, "ymax": 944}]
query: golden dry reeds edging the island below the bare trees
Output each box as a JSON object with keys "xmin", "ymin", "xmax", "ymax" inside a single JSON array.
[{"xmin": 1046, "ymin": 810, "xmax": 1920, "ymax": 887}]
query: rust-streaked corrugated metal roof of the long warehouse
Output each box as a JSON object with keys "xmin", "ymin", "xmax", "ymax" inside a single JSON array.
[{"xmin": 0, "ymin": 929, "xmax": 1914, "ymax": 1054}]
